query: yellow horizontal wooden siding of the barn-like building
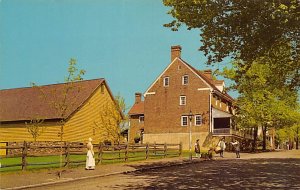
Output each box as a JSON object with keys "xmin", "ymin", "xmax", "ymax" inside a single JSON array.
[{"xmin": 0, "ymin": 85, "xmax": 120, "ymax": 143}]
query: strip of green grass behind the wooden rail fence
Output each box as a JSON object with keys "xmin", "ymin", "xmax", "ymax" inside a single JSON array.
[{"xmin": 0, "ymin": 151, "xmax": 189, "ymax": 172}]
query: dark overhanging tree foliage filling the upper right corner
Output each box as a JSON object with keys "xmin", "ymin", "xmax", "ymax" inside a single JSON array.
[{"xmin": 163, "ymin": 0, "xmax": 300, "ymax": 87}]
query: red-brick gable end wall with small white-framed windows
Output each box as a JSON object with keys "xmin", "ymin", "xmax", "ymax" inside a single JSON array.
[{"xmin": 145, "ymin": 59, "xmax": 210, "ymax": 134}]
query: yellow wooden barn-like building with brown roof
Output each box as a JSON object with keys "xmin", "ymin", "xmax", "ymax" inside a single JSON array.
[{"xmin": 0, "ymin": 79, "xmax": 123, "ymax": 144}]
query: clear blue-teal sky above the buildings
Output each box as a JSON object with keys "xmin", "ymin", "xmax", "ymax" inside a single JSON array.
[{"xmin": 0, "ymin": 0, "xmax": 234, "ymax": 107}]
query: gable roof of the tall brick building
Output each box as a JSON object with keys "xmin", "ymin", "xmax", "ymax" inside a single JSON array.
[{"xmin": 145, "ymin": 57, "xmax": 234, "ymax": 101}]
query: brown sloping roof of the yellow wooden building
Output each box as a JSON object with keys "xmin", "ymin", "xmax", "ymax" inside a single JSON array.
[{"xmin": 0, "ymin": 79, "xmax": 105, "ymax": 122}]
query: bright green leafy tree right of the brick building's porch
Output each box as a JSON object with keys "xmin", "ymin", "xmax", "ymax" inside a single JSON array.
[{"xmin": 222, "ymin": 58, "xmax": 300, "ymax": 149}]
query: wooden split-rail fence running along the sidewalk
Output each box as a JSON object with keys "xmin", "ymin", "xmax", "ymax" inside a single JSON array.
[{"xmin": 0, "ymin": 141, "xmax": 182, "ymax": 170}]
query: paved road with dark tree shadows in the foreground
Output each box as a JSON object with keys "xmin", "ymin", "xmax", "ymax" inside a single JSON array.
[{"xmin": 33, "ymin": 151, "xmax": 300, "ymax": 190}]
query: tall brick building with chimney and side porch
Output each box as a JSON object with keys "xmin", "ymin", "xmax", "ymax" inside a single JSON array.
[{"xmin": 129, "ymin": 46, "xmax": 248, "ymax": 149}]
